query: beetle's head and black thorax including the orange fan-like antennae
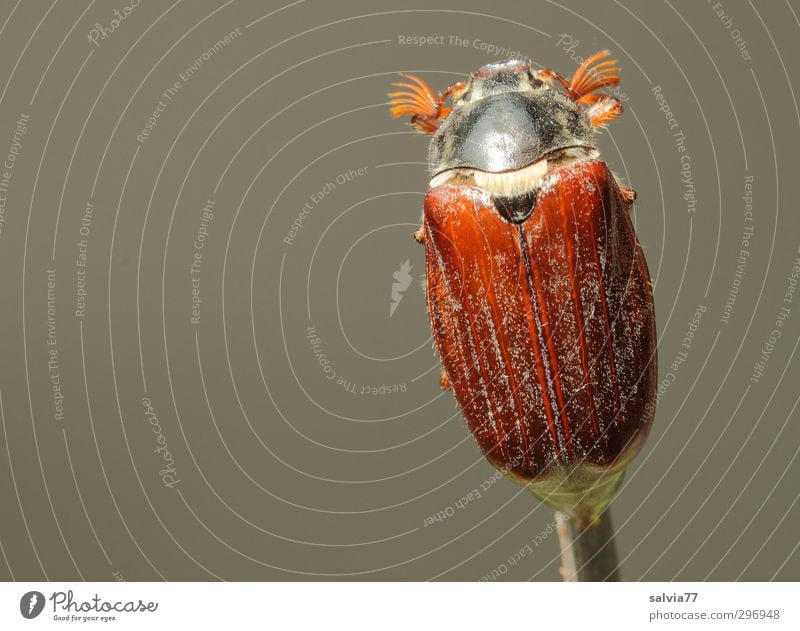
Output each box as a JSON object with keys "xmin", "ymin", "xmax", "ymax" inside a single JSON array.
[{"xmin": 390, "ymin": 51, "xmax": 622, "ymax": 177}]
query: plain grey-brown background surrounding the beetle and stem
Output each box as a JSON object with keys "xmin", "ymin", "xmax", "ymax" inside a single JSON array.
[{"xmin": 0, "ymin": 0, "xmax": 800, "ymax": 580}]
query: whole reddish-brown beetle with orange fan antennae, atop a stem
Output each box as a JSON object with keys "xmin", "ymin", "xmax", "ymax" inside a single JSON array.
[{"xmin": 389, "ymin": 51, "xmax": 657, "ymax": 524}]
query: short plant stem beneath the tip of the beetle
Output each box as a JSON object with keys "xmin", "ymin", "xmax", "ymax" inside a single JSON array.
[{"xmin": 556, "ymin": 509, "xmax": 620, "ymax": 582}]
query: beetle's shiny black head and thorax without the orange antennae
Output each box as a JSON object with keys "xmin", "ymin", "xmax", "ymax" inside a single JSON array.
[{"xmin": 428, "ymin": 60, "xmax": 595, "ymax": 175}]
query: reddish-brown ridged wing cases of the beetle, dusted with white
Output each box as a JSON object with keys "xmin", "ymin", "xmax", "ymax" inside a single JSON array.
[{"xmin": 424, "ymin": 159, "xmax": 656, "ymax": 516}]
